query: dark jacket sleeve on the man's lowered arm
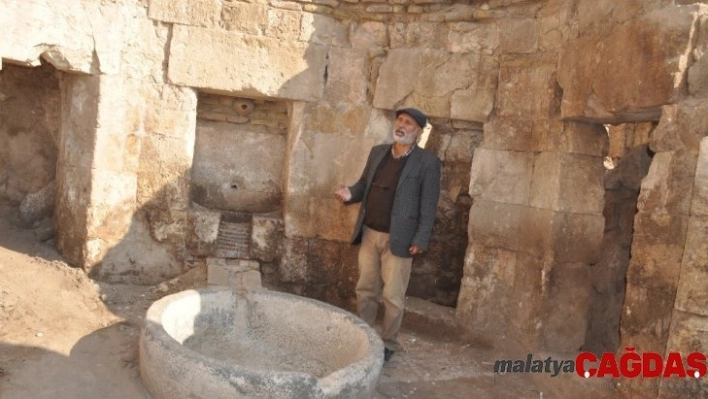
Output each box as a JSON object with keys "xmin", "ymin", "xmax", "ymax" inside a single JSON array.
[{"xmin": 413, "ymin": 157, "xmax": 441, "ymax": 251}]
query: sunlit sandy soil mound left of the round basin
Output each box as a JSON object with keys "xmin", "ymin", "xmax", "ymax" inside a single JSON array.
[{"xmin": 0, "ymin": 204, "xmax": 199, "ymax": 399}]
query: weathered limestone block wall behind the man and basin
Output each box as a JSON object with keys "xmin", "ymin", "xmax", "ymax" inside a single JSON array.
[{"xmin": 0, "ymin": 0, "xmax": 708, "ymax": 397}]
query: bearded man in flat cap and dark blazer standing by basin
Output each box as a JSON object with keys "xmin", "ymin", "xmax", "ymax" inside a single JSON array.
[{"xmin": 335, "ymin": 108, "xmax": 440, "ymax": 361}]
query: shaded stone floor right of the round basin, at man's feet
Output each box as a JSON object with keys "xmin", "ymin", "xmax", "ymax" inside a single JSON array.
[{"xmin": 376, "ymin": 298, "xmax": 617, "ymax": 399}]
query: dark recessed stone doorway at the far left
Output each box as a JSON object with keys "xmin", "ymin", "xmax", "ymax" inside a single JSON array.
[{"xmin": 0, "ymin": 63, "xmax": 61, "ymax": 234}]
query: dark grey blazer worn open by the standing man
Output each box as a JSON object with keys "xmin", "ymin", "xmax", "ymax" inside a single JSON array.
[{"xmin": 346, "ymin": 144, "xmax": 441, "ymax": 258}]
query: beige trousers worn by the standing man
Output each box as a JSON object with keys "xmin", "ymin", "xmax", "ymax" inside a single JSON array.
[{"xmin": 356, "ymin": 226, "xmax": 413, "ymax": 350}]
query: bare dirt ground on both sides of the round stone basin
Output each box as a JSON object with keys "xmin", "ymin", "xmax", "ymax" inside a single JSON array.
[{"xmin": 0, "ymin": 204, "xmax": 613, "ymax": 399}]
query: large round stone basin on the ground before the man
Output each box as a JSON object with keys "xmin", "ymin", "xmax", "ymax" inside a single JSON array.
[{"xmin": 140, "ymin": 288, "xmax": 383, "ymax": 399}]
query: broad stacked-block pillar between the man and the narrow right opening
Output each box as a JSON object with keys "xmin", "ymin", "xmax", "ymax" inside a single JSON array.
[{"xmin": 457, "ymin": 56, "xmax": 607, "ymax": 351}]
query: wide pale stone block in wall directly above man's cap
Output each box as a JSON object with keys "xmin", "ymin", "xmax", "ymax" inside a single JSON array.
[{"xmin": 374, "ymin": 49, "xmax": 497, "ymax": 122}]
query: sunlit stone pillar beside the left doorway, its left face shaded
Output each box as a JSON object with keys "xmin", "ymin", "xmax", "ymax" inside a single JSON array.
[{"xmin": 57, "ymin": 75, "xmax": 137, "ymax": 272}]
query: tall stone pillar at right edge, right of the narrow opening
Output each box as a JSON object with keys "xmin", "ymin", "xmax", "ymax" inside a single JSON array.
[{"xmin": 619, "ymin": 100, "xmax": 708, "ymax": 398}]
